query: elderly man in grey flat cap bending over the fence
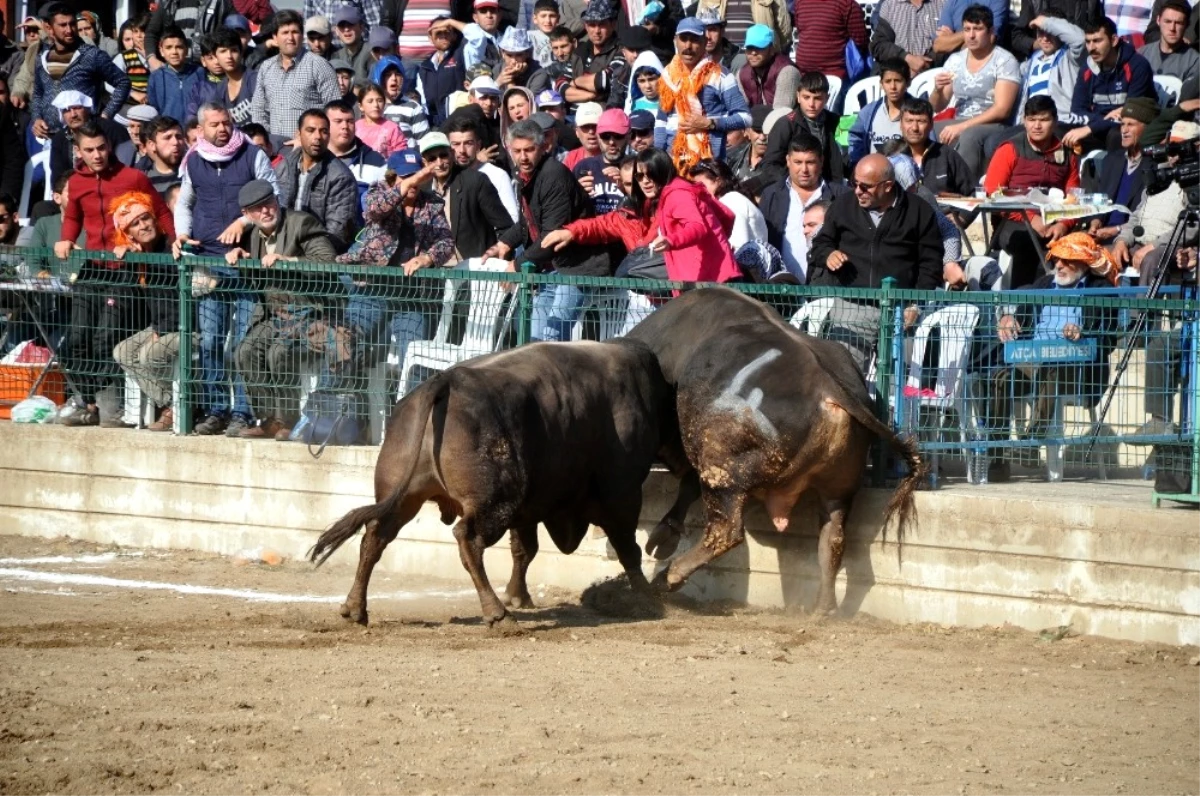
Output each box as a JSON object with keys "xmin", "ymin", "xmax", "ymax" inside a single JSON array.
[{"xmin": 226, "ymin": 180, "xmax": 335, "ymax": 441}]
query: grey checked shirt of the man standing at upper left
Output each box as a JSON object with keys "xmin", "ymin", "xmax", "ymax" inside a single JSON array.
[{"xmin": 250, "ymin": 49, "xmax": 342, "ymax": 139}]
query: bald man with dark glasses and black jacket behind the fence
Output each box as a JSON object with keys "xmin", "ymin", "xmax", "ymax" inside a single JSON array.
[{"xmin": 809, "ymin": 154, "xmax": 943, "ymax": 372}]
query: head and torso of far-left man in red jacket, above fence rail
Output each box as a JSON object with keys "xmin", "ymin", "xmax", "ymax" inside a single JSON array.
[{"xmin": 54, "ymin": 120, "xmax": 175, "ymax": 260}]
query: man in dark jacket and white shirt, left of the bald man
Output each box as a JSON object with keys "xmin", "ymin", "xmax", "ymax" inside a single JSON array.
[{"xmin": 758, "ymin": 133, "xmax": 848, "ymax": 281}]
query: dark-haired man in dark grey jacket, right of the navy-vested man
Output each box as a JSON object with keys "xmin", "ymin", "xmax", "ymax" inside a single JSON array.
[{"xmin": 275, "ymin": 108, "xmax": 359, "ymax": 251}]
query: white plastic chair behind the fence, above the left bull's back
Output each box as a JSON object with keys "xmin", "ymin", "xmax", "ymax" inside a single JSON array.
[{"xmin": 396, "ymin": 258, "xmax": 516, "ymax": 400}]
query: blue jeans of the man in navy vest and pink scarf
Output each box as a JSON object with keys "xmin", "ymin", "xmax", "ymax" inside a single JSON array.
[{"xmin": 199, "ymin": 293, "xmax": 258, "ymax": 423}]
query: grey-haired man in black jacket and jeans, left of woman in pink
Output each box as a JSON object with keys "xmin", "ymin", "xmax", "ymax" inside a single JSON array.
[{"xmin": 508, "ymin": 119, "xmax": 612, "ymax": 340}]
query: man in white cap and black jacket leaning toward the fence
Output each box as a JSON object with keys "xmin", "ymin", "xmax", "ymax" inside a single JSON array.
[{"xmin": 418, "ymin": 132, "xmax": 522, "ymax": 261}]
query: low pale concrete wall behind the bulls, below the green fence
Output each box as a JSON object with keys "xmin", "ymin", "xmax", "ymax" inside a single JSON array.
[{"xmin": 0, "ymin": 423, "xmax": 1200, "ymax": 645}]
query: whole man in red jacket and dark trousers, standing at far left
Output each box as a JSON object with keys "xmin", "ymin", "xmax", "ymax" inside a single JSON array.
[{"xmin": 54, "ymin": 119, "xmax": 175, "ymax": 427}]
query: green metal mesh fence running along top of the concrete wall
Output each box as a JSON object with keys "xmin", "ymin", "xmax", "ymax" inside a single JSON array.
[{"xmin": 0, "ymin": 249, "xmax": 1200, "ymax": 493}]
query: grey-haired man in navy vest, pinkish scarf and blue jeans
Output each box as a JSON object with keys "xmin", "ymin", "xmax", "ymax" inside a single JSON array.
[{"xmin": 173, "ymin": 102, "xmax": 275, "ymax": 436}]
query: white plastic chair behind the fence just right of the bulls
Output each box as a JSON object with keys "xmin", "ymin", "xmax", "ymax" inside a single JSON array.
[{"xmin": 901, "ymin": 304, "xmax": 979, "ymax": 478}]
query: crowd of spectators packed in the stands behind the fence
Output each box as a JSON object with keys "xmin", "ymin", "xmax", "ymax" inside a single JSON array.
[{"xmin": 0, "ymin": 0, "xmax": 1200, "ymax": 480}]
